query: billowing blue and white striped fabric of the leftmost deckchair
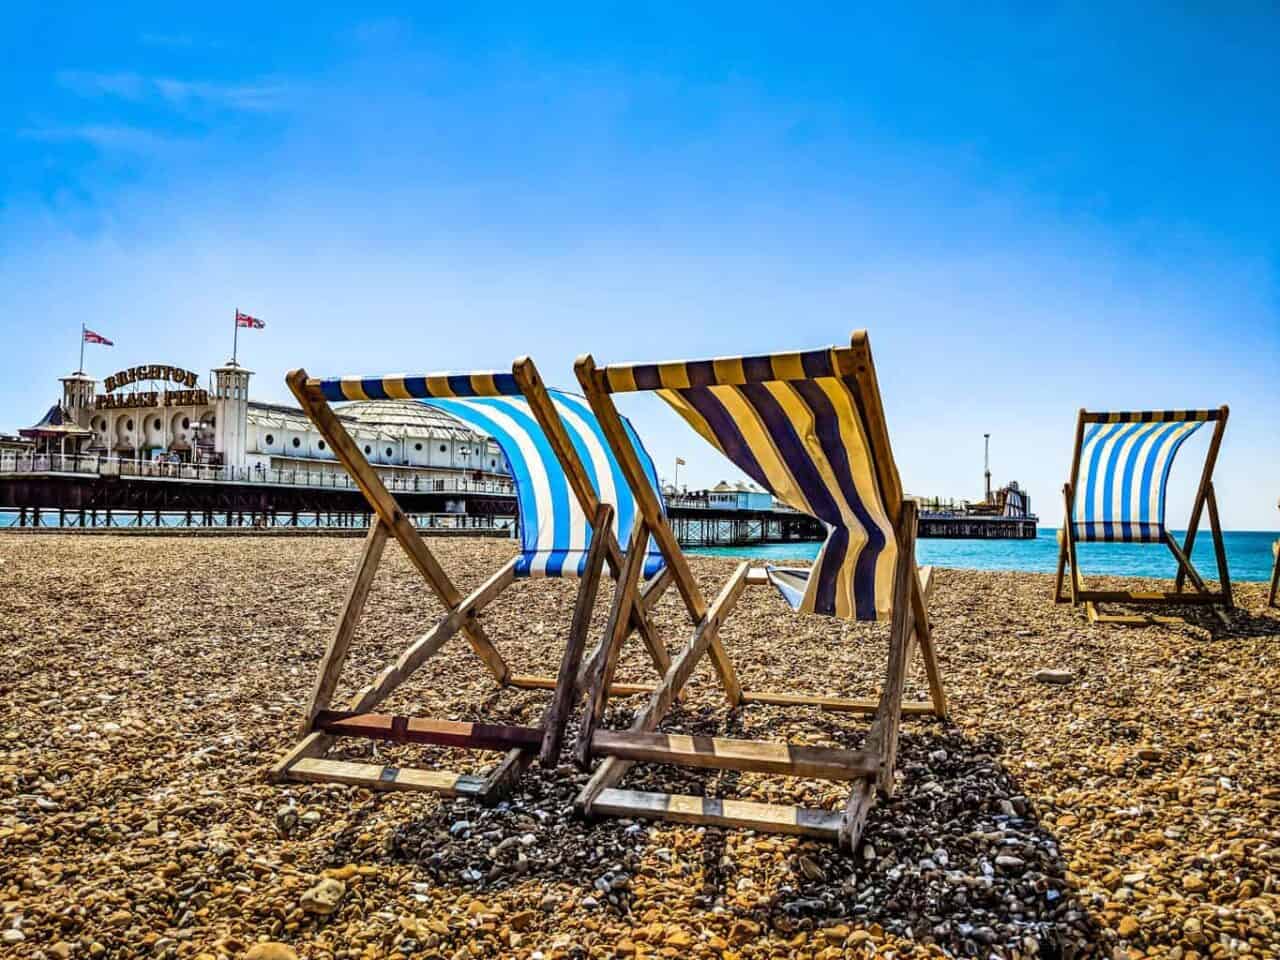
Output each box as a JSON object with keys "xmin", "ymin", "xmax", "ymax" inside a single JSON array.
[{"xmin": 320, "ymin": 372, "xmax": 664, "ymax": 577}]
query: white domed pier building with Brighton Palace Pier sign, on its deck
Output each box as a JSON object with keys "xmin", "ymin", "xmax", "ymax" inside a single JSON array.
[{"xmin": 0, "ymin": 362, "xmax": 515, "ymax": 527}]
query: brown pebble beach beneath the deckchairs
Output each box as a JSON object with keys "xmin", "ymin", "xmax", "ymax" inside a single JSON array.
[{"xmin": 0, "ymin": 535, "xmax": 1280, "ymax": 957}]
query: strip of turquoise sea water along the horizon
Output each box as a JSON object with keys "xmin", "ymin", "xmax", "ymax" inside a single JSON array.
[{"xmin": 689, "ymin": 527, "xmax": 1280, "ymax": 582}]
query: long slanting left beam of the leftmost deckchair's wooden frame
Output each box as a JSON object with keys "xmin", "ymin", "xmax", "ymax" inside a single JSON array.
[{"xmin": 285, "ymin": 370, "xmax": 509, "ymax": 684}]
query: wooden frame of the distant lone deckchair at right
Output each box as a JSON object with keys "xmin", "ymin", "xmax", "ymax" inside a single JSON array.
[{"xmin": 1053, "ymin": 404, "xmax": 1234, "ymax": 625}]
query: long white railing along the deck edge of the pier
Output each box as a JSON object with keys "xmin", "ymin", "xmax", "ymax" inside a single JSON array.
[{"xmin": 0, "ymin": 453, "xmax": 515, "ymax": 497}]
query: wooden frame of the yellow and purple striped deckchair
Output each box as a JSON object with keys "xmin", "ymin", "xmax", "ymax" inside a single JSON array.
[{"xmin": 565, "ymin": 330, "xmax": 947, "ymax": 849}]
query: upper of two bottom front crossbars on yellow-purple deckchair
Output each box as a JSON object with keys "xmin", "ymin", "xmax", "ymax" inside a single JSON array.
[{"xmin": 591, "ymin": 730, "xmax": 879, "ymax": 780}]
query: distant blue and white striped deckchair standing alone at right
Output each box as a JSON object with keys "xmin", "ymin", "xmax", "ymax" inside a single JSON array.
[{"xmin": 1053, "ymin": 406, "xmax": 1231, "ymax": 623}]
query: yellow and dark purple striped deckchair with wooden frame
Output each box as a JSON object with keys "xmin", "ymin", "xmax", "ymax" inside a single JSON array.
[{"xmin": 565, "ymin": 332, "xmax": 946, "ymax": 846}]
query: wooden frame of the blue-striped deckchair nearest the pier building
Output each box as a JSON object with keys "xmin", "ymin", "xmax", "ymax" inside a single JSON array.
[{"xmin": 271, "ymin": 357, "xmax": 672, "ymax": 801}]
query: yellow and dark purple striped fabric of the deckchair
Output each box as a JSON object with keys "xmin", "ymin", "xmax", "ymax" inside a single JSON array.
[{"xmin": 608, "ymin": 348, "xmax": 897, "ymax": 620}]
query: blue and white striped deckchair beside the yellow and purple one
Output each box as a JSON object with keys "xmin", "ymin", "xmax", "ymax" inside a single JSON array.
[{"xmin": 267, "ymin": 357, "xmax": 671, "ymax": 799}]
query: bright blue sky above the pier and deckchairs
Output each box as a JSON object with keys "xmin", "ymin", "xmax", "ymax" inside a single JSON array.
[{"xmin": 0, "ymin": 4, "xmax": 1280, "ymax": 529}]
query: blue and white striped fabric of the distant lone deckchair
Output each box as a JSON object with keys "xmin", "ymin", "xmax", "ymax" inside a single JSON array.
[{"xmin": 1073, "ymin": 410, "xmax": 1220, "ymax": 543}]
